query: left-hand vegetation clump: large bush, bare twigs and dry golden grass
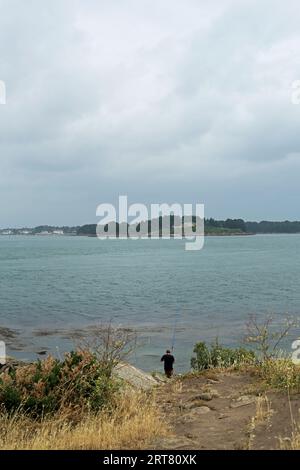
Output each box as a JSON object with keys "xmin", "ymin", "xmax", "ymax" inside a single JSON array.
[{"xmin": 0, "ymin": 325, "xmax": 165, "ymax": 449}]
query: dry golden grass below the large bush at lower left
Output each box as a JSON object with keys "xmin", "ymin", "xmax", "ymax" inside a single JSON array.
[{"xmin": 0, "ymin": 390, "xmax": 167, "ymax": 450}]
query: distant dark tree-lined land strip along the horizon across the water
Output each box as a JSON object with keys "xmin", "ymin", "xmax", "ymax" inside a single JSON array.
[{"xmin": 0, "ymin": 215, "xmax": 300, "ymax": 237}]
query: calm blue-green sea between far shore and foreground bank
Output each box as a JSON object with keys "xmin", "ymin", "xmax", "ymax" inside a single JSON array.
[{"xmin": 0, "ymin": 235, "xmax": 300, "ymax": 371}]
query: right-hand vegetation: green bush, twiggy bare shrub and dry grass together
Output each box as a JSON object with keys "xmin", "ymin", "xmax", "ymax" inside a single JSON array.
[{"xmin": 191, "ymin": 315, "xmax": 300, "ymax": 393}]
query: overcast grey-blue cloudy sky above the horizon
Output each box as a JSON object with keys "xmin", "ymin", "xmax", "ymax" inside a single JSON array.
[{"xmin": 0, "ymin": 0, "xmax": 300, "ymax": 227}]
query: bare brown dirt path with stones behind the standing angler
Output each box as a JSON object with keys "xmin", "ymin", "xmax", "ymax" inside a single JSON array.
[{"xmin": 154, "ymin": 373, "xmax": 300, "ymax": 450}]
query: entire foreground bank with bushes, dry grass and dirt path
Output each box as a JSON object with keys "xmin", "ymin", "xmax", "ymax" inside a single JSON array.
[{"xmin": 0, "ymin": 317, "xmax": 300, "ymax": 449}]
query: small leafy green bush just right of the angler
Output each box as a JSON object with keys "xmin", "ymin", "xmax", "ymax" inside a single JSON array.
[{"xmin": 191, "ymin": 340, "xmax": 256, "ymax": 371}]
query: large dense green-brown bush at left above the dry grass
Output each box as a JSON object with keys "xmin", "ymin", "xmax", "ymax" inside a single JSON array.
[{"xmin": 0, "ymin": 351, "xmax": 120, "ymax": 417}]
